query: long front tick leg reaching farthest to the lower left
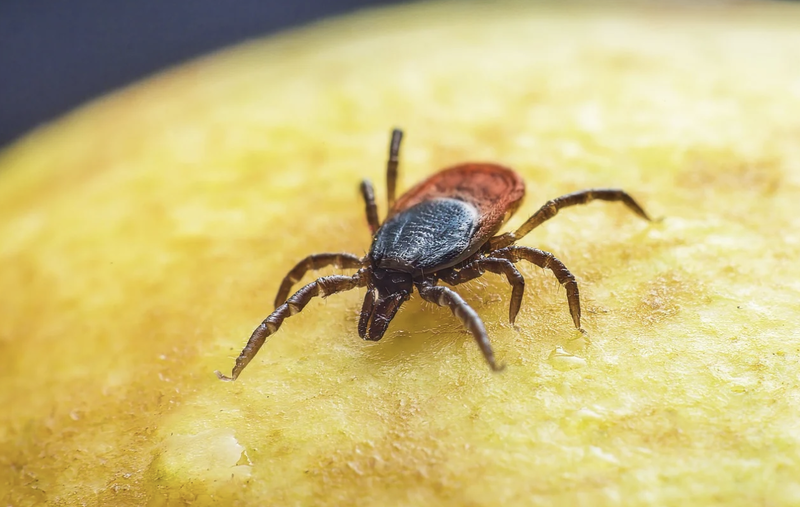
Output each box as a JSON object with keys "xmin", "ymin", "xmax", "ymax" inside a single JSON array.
[{"xmin": 215, "ymin": 271, "xmax": 367, "ymax": 381}]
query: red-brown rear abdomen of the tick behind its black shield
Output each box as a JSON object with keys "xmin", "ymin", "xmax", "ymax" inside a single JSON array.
[{"xmin": 387, "ymin": 164, "xmax": 525, "ymax": 244}]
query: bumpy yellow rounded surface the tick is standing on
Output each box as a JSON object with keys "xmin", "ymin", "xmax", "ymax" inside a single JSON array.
[{"xmin": 0, "ymin": 3, "xmax": 800, "ymax": 507}]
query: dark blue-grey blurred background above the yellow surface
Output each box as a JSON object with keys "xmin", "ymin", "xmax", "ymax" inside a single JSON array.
[{"xmin": 0, "ymin": 0, "xmax": 399, "ymax": 148}]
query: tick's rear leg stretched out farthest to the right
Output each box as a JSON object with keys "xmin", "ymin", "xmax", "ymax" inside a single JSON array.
[{"xmin": 489, "ymin": 188, "xmax": 650, "ymax": 249}]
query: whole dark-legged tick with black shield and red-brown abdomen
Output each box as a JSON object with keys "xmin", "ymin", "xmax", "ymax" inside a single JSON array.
[{"xmin": 216, "ymin": 129, "xmax": 650, "ymax": 380}]
